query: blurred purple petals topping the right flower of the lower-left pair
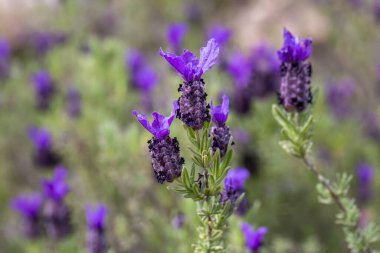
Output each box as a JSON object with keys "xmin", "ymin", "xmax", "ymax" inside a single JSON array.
[{"xmin": 42, "ymin": 165, "xmax": 70, "ymax": 202}]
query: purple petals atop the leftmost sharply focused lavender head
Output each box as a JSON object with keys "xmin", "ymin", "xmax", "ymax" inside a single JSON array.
[{"xmin": 132, "ymin": 101, "xmax": 178, "ymax": 140}]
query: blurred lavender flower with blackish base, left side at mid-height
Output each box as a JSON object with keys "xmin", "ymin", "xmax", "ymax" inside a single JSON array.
[{"xmin": 28, "ymin": 127, "xmax": 60, "ymax": 167}]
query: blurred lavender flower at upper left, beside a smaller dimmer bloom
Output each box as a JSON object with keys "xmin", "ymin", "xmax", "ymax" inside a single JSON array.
[{"xmin": 32, "ymin": 70, "xmax": 54, "ymax": 110}]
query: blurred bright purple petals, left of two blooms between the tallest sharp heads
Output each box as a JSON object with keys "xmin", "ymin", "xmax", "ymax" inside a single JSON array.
[{"xmin": 227, "ymin": 53, "xmax": 252, "ymax": 88}]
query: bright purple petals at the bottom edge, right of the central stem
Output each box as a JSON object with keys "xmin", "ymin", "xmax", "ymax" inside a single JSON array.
[{"xmin": 241, "ymin": 223, "xmax": 268, "ymax": 253}]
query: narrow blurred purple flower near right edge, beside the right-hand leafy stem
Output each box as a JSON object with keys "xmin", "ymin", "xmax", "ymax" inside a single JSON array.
[{"xmin": 357, "ymin": 163, "xmax": 374, "ymax": 204}]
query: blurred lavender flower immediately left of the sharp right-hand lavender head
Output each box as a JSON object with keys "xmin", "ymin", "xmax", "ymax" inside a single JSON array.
[{"xmin": 250, "ymin": 44, "xmax": 280, "ymax": 98}]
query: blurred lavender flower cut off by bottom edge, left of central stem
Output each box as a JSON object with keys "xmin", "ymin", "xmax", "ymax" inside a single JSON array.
[{"xmin": 86, "ymin": 203, "xmax": 107, "ymax": 253}]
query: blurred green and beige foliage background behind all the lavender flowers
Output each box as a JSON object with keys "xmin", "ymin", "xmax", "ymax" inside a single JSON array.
[{"xmin": 0, "ymin": 0, "xmax": 380, "ymax": 253}]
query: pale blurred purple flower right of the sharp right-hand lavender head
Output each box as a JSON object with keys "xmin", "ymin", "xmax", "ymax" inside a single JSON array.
[{"xmin": 326, "ymin": 79, "xmax": 356, "ymax": 119}]
